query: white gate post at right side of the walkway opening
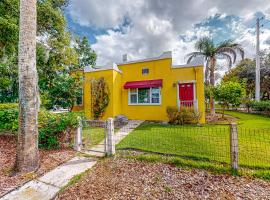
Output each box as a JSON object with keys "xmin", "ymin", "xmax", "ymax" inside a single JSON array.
[{"xmin": 105, "ymin": 118, "xmax": 115, "ymax": 156}]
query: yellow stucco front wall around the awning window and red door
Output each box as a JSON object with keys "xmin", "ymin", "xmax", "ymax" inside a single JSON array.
[{"xmin": 118, "ymin": 59, "xmax": 205, "ymax": 123}]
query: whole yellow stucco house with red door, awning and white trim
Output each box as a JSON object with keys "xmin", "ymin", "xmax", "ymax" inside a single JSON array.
[{"xmin": 74, "ymin": 52, "xmax": 205, "ymax": 123}]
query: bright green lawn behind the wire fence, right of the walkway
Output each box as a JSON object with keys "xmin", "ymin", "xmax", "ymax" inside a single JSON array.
[{"xmin": 117, "ymin": 112, "xmax": 270, "ymax": 169}]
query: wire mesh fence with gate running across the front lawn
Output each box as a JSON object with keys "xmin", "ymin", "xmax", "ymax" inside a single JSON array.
[{"xmin": 75, "ymin": 120, "xmax": 270, "ymax": 170}]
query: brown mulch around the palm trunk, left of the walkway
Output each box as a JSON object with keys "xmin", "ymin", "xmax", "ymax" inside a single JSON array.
[{"xmin": 0, "ymin": 135, "xmax": 75, "ymax": 197}]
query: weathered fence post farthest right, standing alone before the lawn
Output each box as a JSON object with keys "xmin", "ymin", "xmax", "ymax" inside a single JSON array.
[{"xmin": 230, "ymin": 123, "xmax": 238, "ymax": 171}]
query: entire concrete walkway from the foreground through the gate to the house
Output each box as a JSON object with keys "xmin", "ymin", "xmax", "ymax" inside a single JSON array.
[{"xmin": 0, "ymin": 121, "xmax": 143, "ymax": 200}]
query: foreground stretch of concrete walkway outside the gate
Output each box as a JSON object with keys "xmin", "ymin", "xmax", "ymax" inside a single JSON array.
[{"xmin": 1, "ymin": 157, "xmax": 97, "ymax": 200}]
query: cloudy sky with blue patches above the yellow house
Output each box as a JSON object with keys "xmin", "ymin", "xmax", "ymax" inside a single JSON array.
[{"xmin": 66, "ymin": 0, "xmax": 270, "ymax": 66}]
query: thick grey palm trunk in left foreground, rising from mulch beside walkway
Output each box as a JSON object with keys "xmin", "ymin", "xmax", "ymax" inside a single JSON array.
[{"xmin": 15, "ymin": 0, "xmax": 39, "ymax": 172}]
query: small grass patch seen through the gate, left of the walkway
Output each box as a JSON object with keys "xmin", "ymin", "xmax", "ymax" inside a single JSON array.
[{"xmin": 83, "ymin": 127, "xmax": 105, "ymax": 148}]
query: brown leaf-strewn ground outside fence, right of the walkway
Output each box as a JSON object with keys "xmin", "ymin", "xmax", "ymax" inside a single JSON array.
[{"xmin": 55, "ymin": 158, "xmax": 270, "ymax": 200}]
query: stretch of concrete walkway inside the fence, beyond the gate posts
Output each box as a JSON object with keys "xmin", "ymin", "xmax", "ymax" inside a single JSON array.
[{"xmin": 82, "ymin": 120, "xmax": 144, "ymax": 157}]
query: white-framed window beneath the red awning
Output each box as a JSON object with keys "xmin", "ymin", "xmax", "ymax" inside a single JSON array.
[{"xmin": 129, "ymin": 88, "xmax": 161, "ymax": 105}]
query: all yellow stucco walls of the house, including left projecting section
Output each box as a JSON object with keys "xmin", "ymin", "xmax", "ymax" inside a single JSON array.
[{"xmin": 79, "ymin": 58, "xmax": 205, "ymax": 123}]
